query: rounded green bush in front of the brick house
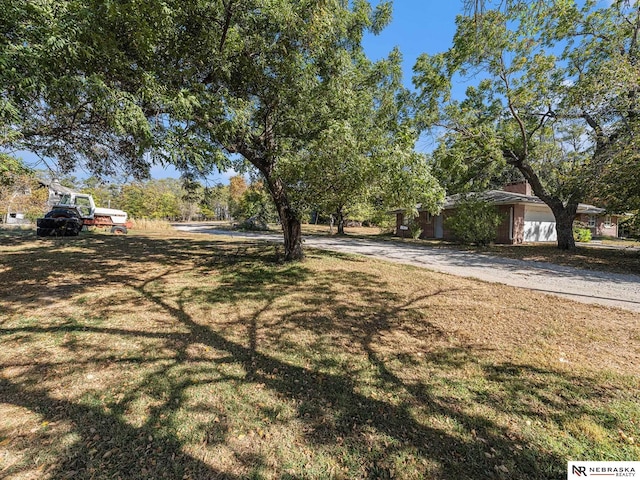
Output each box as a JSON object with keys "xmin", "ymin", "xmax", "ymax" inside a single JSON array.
[{"xmin": 445, "ymin": 195, "xmax": 503, "ymax": 245}]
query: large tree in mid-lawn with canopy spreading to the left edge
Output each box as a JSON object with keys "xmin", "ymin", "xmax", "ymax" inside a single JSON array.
[{"xmin": 1, "ymin": 0, "xmax": 440, "ymax": 259}]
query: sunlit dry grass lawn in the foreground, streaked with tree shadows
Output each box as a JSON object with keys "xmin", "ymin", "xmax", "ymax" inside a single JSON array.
[{"xmin": 0, "ymin": 231, "xmax": 640, "ymax": 480}]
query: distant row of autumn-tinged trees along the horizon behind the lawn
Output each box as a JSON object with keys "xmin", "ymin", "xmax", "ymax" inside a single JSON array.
[{"xmin": 0, "ymin": 155, "xmax": 404, "ymax": 231}]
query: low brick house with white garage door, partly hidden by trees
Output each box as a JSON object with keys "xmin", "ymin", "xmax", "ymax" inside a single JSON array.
[{"xmin": 394, "ymin": 182, "xmax": 619, "ymax": 244}]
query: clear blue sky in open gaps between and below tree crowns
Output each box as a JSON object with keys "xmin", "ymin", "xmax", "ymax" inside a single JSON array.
[{"xmin": 16, "ymin": 0, "xmax": 462, "ymax": 183}]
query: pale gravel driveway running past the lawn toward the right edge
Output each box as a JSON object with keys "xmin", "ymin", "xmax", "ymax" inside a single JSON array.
[{"xmin": 176, "ymin": 224, "xmax": 640, "ymax": 312}]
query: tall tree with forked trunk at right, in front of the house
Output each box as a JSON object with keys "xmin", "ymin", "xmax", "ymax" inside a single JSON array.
[{"xmin": 414, "ymin": 1, "xmax": 640, "ymax": 249}]
